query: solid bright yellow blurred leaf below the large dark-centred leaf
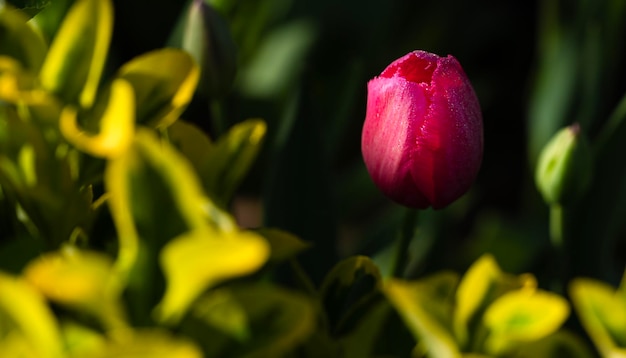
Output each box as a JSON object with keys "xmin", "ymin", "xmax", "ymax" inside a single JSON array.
[{"xmin": 157, "ymin": 231, "xmax": 269, "ymax": 322}]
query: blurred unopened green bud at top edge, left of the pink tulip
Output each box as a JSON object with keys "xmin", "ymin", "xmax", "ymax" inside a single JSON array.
[{"xmin": 169, "ymin": 0, "xmax": 237, "ymax": 97}]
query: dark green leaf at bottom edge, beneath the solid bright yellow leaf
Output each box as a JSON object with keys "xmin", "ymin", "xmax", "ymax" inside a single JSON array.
[{"xmin": 181, "ymin": 284, "xmax": 316, "ymax": 358}]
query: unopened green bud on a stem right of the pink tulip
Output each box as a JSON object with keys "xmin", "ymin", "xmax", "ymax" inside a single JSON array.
[{"xmin": 535, "ymin": 124, "xmax": 592, "ymax": 205}]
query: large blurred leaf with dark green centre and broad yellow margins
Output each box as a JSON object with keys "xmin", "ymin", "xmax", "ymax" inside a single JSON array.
[{"xmin": 105, "ymin": 129, "xmax": 236, "ymax": 290}]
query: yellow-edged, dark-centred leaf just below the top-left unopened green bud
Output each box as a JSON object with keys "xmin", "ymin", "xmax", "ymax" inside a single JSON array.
[{"xmin": 117, "ymin": 48, "xmax": 200, "ymax": 128}]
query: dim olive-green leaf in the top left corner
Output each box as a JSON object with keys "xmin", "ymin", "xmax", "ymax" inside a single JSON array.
[{"xmin": 0, "ymin": 6, "xmax": 47, "ymax": 74}]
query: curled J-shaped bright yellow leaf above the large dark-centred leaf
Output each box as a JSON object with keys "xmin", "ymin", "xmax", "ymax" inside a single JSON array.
[{"xmin": 59, "ymin": 79, "xmax": 135, "ymax": 158}]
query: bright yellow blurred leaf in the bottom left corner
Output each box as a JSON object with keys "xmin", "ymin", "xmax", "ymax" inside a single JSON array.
[{"xmin": 0, "ymin": 272, "xmax": 62, "ymax": 357}]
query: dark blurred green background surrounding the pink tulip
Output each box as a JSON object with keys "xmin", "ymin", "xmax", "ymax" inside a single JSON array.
[{"xmin": 109, "ymin": 0, "xmax": 626, "ymax": 283}]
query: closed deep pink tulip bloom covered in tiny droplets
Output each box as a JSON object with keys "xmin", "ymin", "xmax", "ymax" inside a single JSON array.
[{"xmin": 361, "ymin": 51, "xmax": 483, "ymax": 209}]
